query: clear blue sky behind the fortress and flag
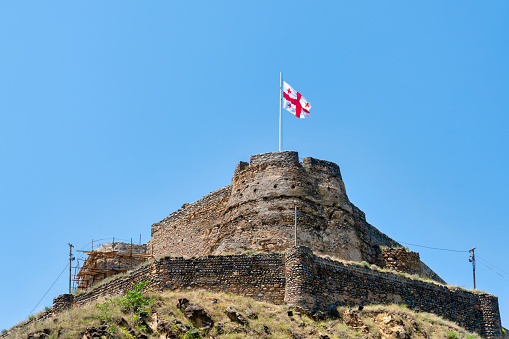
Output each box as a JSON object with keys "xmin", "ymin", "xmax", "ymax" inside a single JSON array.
[{"xmin": 0, "ymin": 0, "xmax": 509, "ymax": 329}]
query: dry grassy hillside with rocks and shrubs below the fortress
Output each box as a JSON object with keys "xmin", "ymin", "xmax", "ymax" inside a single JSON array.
[{"xmin": 2, "ymin": 289, "xmax": 480, "ymax": 339}]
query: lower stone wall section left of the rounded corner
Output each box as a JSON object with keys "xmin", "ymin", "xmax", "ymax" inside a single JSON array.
[{"xmin": 71, "ymin": 253, "xmax": 285, "ymax": 308}]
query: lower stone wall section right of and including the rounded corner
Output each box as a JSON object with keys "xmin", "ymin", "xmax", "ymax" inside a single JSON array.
[{"xmin": 285, "ymin": 247, "xmax": 501, "ymax": 338}]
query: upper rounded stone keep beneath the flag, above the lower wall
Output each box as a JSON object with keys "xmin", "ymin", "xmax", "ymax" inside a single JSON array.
[{"xmin": 149, "ymin": 151, "xmax": 440, "ymax": 278}]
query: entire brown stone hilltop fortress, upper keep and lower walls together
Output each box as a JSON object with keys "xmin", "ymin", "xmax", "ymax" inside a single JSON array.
[{"xmin": 12, "ymin": 151, "xmax": 502, "ymax": 338}]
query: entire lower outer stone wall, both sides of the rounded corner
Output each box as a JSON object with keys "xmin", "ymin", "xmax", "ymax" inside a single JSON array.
[{"xmin": 47, "ymin": 246, "xmax": 501, "ymax": 338}]
